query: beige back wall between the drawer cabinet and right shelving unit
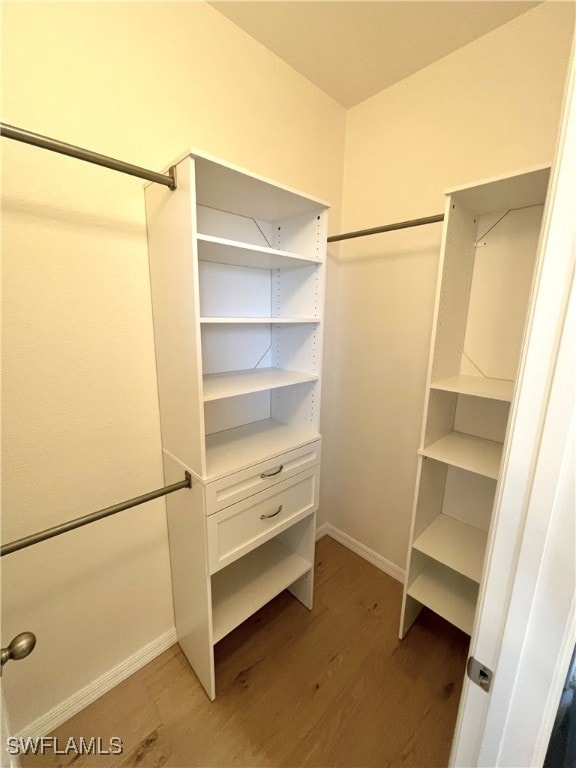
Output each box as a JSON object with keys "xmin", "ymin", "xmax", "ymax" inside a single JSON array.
[{"xmin": 325, "ymin": 3, "xmax": 574, "ymax": 568}]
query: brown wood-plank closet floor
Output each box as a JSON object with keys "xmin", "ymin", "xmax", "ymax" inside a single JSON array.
[{"xmin": 23, "ymin": 537, "xmax": 468, "ymax": 768}]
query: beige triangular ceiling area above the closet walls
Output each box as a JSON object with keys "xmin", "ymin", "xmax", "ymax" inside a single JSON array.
[{"xmin": 210, "ymin": 0, "xmax": 539, "ymax": 108}]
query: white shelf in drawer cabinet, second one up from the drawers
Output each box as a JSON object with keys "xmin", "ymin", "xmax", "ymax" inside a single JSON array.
[{"xmin": 204, "ymin": 368, "xmax": 318, "ymax": 402}]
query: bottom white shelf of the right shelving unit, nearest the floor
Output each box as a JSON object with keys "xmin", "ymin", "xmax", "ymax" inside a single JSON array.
[{"xmin": 408, "ymin": 561, "xmax": 478, "ymax": 635}]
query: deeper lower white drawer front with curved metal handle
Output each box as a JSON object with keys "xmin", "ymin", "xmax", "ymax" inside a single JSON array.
[{"xmin": 206, "ymin": 469, "xmax": 319, "ymax": 573}]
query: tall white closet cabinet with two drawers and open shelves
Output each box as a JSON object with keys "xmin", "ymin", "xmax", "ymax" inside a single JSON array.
[{"xmin": 146, "ymin": 152, "xmax": 328, "ymax": 699}]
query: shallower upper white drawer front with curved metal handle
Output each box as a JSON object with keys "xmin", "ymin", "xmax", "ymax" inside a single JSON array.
[{"xmin": 206, "ymin": 440, "xmax": 320, "ymax": 515}]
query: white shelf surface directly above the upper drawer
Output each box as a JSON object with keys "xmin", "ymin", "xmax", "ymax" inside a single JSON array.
[{"xmin": 205, "ymin": 419, "xmax": 320, "ymax": 482}]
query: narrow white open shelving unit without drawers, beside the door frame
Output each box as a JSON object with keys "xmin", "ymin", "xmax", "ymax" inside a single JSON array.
[{"xmin": 400, "ymin": 168, "xmax": 549, "ymax": 637}]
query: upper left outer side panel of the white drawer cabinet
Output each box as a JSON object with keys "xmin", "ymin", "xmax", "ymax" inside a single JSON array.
[{"xmin": 146, "ymin": 160, "xmax": 206, "ymax": 475}]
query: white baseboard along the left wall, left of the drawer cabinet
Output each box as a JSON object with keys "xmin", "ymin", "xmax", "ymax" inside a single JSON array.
[{"xmin": 15, "ymin": 627, "xmax": 176, "ymax": 738}]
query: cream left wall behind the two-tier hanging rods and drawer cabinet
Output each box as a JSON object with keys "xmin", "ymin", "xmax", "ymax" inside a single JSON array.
[{"xmin": 2, "ymin": 2, "xmax": 345, "ymax": 730}]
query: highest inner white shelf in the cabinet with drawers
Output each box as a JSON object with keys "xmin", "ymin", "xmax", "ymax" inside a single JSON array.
[{"xmin": 197, "ymin": 234, "xmax": 319, "ymax": 269}]
